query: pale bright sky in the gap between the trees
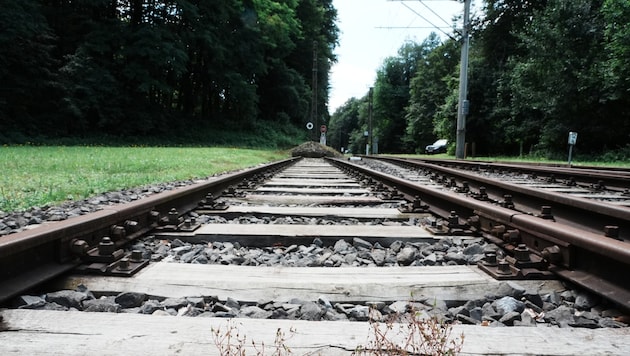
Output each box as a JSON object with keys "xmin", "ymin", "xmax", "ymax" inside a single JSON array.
[{"xmin": 328, "ymin": 0, "xmax": 464, "ymax": 114}]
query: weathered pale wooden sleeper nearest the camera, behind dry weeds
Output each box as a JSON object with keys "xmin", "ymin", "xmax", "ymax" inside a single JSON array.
[{"xmin": 0, "ymin": 310, "xmax": 630, "ymax": 356}]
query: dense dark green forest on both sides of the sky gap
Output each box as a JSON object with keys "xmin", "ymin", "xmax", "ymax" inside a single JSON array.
[{"xmin": 0, "ymin": 0, "xmax": 630, "ymax": 159}]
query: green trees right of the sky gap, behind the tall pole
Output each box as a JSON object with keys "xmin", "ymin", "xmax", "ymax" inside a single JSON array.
[{"xmin": 329, "ymin": 0, "xmax": 630, "ymax": 159}]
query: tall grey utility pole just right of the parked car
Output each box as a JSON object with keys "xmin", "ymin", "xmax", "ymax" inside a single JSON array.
[{"xmin": 455, "ymin": 0, "xmax": 470, "ymax": 159}]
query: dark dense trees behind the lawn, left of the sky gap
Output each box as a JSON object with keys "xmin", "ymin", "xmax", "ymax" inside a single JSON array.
[{"xmin": 0, "ymin": 0, "xmax": 338, "ymax": 140}]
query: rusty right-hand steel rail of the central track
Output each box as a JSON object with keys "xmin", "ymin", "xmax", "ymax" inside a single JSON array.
[{"xmin": 330, "ymin": 159, "xmax": 630, "ymax": 309}]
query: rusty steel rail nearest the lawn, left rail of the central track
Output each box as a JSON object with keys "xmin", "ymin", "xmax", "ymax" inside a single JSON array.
[{"xmin": 0, "ymin": 158, "xmax": 299, "ymax": 303}]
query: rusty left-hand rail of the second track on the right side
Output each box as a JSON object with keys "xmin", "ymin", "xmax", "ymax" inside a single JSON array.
[{"xmin": 376, "ymin": 157, "xmax": 630, "ymax": 240}]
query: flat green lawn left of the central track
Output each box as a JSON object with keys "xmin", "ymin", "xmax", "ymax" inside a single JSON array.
[{"xmin": 0, "ymin": 146, "xmax": 288, "ymax": 212}]
